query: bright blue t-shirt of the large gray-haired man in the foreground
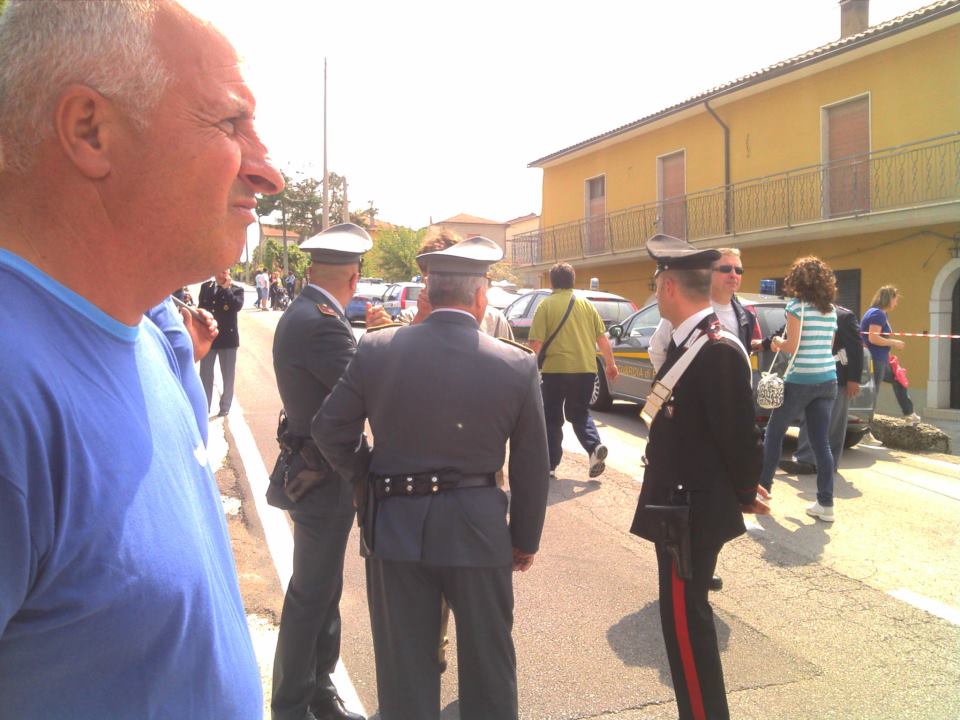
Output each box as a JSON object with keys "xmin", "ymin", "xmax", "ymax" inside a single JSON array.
[{"xmin": 0, "ymin": 250, "xmax": 263, "ymax": 720}]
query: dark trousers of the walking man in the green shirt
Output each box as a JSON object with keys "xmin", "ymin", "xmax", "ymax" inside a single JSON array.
[{"xmin": 540, "ymin": 373, "xmax": 600, "ymax": 470}]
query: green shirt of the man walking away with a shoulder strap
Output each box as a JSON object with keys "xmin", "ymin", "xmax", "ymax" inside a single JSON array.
[{"xmin": 530, "ymin": 290, "xmax": 605, "ymax": 373}]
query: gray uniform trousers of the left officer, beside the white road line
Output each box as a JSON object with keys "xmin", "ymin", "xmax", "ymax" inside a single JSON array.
[{"xmin": 270, "ymin": 510, "xmax": 354, "ymax": 720}]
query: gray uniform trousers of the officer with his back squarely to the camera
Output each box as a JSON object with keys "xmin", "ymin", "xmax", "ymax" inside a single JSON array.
[{"xmin": 367, "ymin": 559, "xmax": 517, "ymax": 720}]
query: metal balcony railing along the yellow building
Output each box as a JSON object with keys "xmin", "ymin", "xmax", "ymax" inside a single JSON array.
[{"xmin": 511, "ymin": 132, "xmax": 960, "ymax": 266}]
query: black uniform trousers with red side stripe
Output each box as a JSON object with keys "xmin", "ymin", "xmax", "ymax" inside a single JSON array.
[{"xmin": 656, "ymin": 545, "xmax": 730, "ymax": 720}]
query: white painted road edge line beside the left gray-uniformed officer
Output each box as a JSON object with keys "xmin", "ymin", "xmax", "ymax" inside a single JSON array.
[{"xmin": 229, "ymin": 397, "xmax": 367, "ymax": 717}]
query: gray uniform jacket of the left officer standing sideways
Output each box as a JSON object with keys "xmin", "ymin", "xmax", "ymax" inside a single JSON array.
[{"xmin": 273, "ymin": 286, "xmax": 357, "ymax": 514}]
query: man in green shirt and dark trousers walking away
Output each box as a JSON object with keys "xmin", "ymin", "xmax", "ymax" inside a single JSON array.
[{"xmin": 530, "ymin": 263, "xmax": 619, "ymax": 478}]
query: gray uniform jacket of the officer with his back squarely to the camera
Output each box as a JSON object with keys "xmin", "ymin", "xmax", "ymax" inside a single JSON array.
[{"xmin": 313, "ymin": 310, "xmax": 549, "ymax": 567}]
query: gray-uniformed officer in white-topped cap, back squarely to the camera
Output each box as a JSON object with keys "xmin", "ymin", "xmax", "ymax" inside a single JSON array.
[{"xmin": 313, "ymin": 237, "xmax": 550, "ymax": 720}]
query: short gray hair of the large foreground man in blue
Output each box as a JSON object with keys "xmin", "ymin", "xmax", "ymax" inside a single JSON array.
[{"xmin": 0, "ymin": 0, "xmax": 170, "ymax": 174}]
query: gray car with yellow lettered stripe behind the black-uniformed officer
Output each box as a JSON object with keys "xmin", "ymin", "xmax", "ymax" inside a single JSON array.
[{"xmin": 590, "ymin": 294, "xmax": 876, "ymax": 447}]
